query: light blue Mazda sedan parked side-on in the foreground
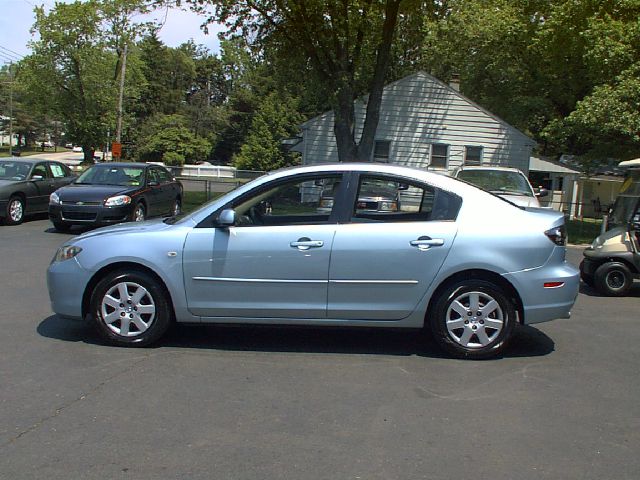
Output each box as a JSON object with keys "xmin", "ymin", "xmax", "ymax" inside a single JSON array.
[{"xmin": 47, "ymin": 164, "xmax": 579, "ymax": 358}]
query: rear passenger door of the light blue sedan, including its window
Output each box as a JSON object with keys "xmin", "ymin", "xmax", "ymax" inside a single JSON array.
[{"xmin": 327, "ymin": 174, "xmax": 461, "ymax": 321}]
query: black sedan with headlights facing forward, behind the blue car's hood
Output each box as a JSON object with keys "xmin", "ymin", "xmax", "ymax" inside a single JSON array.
[{"xmin": 49, "ymin": 163, "xmax": 182, "ymax": 231}]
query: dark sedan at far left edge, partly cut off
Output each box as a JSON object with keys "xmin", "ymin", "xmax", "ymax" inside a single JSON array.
[{"xmin": 0, "ymin": 157, "xmax": 75, "ymax": 225}]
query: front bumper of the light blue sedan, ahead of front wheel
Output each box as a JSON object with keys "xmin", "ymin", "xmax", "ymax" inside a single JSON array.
[{"xmin": 47, "ymin": 258, "xmax": 92, "ymax": 319}]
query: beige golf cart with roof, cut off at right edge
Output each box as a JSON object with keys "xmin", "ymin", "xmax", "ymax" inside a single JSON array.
[{"xmin": 580, "ymin": 158, "xmax": 640, "ymax": 296}]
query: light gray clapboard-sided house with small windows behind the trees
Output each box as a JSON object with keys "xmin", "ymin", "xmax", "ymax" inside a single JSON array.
[{"xmin": 292, "ymin": 72, "xmax": 535, "ymax": 174}]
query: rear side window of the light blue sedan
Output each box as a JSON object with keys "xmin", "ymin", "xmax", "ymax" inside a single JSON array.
[{"xmin": 352, "ymin": 175, "xmax": 462, "ymax": 222}]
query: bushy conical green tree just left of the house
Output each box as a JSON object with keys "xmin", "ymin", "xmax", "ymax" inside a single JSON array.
[{"xmin": 233, "ymin": 93, "xmax": 302, "ymax": 171}]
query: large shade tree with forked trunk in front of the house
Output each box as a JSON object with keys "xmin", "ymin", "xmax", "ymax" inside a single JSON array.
[{"xmin": 188, "ymin": 0, "xmax": 404, "ymax": 161}]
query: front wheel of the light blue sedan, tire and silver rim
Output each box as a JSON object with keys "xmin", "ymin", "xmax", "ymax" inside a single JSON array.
[{"xmin": 91, "ymin": 270, "xmax": 173, "ymax": 347}]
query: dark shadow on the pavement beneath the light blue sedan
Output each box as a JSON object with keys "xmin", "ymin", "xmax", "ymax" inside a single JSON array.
[{"xmin": 37, "ymin": 315, "xmax": 555, "ymax": 358}]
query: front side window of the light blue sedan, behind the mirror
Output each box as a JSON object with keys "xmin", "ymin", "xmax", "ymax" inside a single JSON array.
[{"xmin": 227, "ymin": 175, "xmax": 342, "ymax": 226}]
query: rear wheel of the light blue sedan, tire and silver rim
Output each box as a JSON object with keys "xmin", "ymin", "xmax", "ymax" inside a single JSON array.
[{"xmin": 430, "ymin": 279, "xmax": 516, "ymax": 359}]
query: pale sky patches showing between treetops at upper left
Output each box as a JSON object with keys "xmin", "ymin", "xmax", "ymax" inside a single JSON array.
[{"xmin": 0, "ymin": 0, "xmax": 221, "ymax": 65}]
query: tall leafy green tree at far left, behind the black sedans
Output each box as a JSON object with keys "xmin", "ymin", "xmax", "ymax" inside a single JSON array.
[{"xmin": 18, "ymin": 0, "xmax": 155, "ymax": 161}]
